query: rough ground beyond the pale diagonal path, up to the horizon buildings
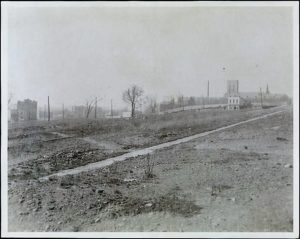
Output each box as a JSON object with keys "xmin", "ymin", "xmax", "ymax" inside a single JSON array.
[{"xmin": 8, "ymin": 106, "xmax": 284, "ymax": 180}]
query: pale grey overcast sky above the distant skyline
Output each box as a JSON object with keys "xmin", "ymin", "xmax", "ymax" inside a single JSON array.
[{"xmin": 8, "ymin": 7, "xmax": 293, "ymax": 109}]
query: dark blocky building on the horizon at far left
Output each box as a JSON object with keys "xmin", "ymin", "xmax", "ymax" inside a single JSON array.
[{"xmin": 14, "ymin": 99, "xmax": 37, "ymax": 121}]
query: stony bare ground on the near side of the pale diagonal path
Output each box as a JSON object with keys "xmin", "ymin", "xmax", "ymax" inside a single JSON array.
[{"xmin": 9, "ymin": 106, "xmax": 293, "ymax": 231}]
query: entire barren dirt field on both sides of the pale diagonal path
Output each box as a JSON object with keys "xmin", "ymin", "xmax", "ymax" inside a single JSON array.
[{"xmin": 8, "ymin": 108, "xmax": 293, "ymax": 232}]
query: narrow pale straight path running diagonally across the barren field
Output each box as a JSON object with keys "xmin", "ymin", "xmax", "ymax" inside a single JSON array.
[{"xmin": 40, "ymin": 110, "xmax": 285, "ymax": 180}]
